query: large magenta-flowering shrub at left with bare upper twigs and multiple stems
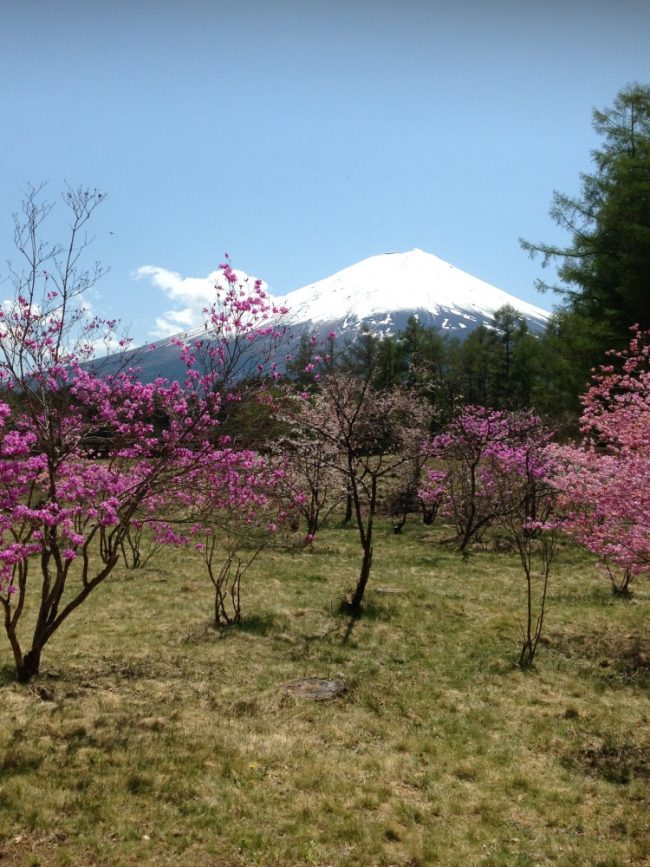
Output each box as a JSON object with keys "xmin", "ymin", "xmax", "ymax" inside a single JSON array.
[{"xmin": 0, "ymin": 190, "xmax": 290, "ymax": 681}]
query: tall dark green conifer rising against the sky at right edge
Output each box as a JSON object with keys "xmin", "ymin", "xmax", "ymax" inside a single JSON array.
[{"xmin": 521, "ymin": 84, "xmax": 650, "ymax": 393}]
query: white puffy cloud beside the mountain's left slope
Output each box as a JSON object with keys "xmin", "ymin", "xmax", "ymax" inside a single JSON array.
[{"xmin": 134, "ymin": 265, "xmax": 268, "ymax": 338}]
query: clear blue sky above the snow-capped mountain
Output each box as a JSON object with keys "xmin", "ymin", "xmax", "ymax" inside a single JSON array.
[{"xmin": 0, "ymin": 0, "xmax": 650, "ymax": 342}]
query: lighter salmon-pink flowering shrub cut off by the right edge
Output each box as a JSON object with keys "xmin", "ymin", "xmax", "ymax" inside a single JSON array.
[{"xmin": 553, "ymin": 328, "xmax": 650, "ymax": 594}]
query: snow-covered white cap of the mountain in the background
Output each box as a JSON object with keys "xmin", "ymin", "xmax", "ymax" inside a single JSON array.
[{"xmin": 282, "ymin": 249, "xmax": 549, "ymax": 331}]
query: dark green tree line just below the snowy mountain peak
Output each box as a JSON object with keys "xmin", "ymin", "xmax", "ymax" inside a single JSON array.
[{"xmin": 287, "ymin": 305, "xmax": 589, "ymax": 433}]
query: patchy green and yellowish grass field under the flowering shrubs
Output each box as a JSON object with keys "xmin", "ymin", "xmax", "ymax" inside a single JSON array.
[{"xmin": 0, "ymin": 522, "xmax": 650, "ymax": 867}]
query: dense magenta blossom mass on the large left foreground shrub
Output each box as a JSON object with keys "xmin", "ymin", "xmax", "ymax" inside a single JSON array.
[{"xmin": 0, "ymin": 368, "xmax": 225, "ymax": 590}]
